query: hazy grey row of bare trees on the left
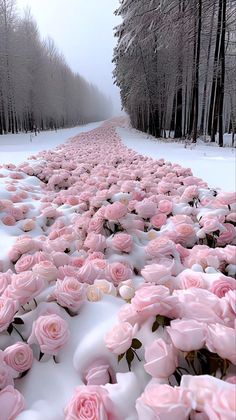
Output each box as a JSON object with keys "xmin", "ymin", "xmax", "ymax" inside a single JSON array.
[{"xmin": 0, "ymin": 0, "xmax": 112, "ymax": 134}]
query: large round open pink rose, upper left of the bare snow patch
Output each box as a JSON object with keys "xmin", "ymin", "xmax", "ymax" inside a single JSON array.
[{"xmin": 28, "ymin": 314, "xmax": 70, "ymax": 355}]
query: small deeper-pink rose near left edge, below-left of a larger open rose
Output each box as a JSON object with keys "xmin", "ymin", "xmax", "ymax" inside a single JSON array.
[{"xmin": 4, "ymin": 341, "xmax": 33, "ymax": 373}]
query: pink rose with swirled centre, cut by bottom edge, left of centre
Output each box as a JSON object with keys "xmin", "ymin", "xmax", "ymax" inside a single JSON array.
[{"xmin": 64, "ymin": 385, "xmax": 116, "ymax": 420}]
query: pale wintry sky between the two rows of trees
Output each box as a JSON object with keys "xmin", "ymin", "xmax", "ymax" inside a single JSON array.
[{"xmin": 17, "ymin": 0, "xmax": 120, "ymax": 113}]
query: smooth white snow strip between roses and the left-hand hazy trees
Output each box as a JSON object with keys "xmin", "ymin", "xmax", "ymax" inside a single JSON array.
[{"xmin": 0, "ymin": 123, "xmax": 101, "ymax": 165}]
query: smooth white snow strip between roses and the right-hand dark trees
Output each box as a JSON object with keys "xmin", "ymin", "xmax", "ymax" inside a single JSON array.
[{"xmin": 118, "ymin": 128, "xmax": 236, "ymax": 191}]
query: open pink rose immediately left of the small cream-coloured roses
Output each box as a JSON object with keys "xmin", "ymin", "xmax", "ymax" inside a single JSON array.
[{"xmin": 50, "ymin": 277, "xmax": 86, "ymax": 312}]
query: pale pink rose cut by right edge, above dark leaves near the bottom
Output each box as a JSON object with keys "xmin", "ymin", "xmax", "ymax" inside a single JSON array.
[{"xmin": 206, "ymin": 324, "xmax": 236, "ymax": 364}]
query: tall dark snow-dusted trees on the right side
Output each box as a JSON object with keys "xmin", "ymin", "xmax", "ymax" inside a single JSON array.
[{"xmin": 114, "ymin": 0, "xmax": 236, "ymax": 146}]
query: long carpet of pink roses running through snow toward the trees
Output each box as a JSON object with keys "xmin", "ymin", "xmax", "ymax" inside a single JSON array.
[{"xmin": 0, "ymin": 121, "xmax": 236, "ymax": 420}]
